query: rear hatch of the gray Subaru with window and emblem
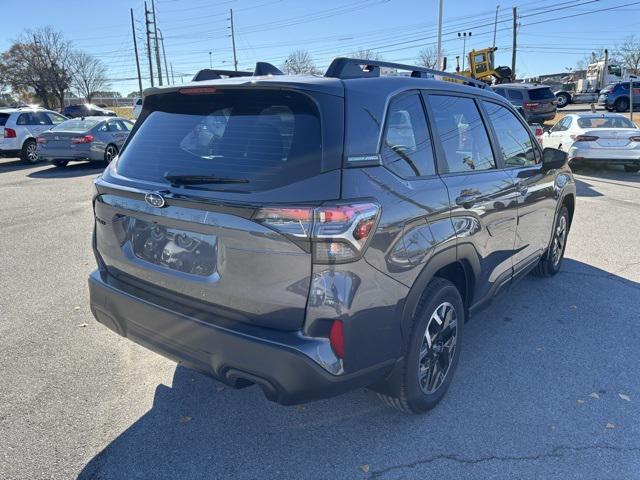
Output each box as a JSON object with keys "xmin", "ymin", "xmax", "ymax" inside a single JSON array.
[{"xmin": 94, "ymin": 87, "xmax": 343, "ymax": 330}]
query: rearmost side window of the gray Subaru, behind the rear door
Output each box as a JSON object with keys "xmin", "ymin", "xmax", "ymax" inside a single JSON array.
[{"xmin": 382, "ymin": 93, "xmax": 435, "ymax": 178}]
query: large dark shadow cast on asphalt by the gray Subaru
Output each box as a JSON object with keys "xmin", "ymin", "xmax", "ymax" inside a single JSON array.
[{"xmin": 78, "ymin": 259, "xmax": 640, "ymax": 480}]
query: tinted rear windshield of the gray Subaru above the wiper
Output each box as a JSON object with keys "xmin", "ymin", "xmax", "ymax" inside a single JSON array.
[{"xmin": 117, "ymin": 90, "xmax": 322, "ymax": 192}]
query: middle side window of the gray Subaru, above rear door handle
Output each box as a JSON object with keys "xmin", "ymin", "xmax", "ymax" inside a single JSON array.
[{"xmin": 429, "ymin": 95, "xmax": 496, "ymax": 172}]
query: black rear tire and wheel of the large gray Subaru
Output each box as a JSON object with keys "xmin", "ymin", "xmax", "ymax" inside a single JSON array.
[{"xmin": 378, "ymin": 277, "xmax": 465, "ymax": 414}]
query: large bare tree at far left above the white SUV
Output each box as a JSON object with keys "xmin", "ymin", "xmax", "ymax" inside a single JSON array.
[{"xmin": 0, "ymin": 27, "xmax": 72, "ymax": 108}]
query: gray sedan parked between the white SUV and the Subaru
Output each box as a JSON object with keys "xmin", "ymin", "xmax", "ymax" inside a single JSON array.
[{"xmin": 36, "ymin": 117, "xmax": 133, "ymax": 167}]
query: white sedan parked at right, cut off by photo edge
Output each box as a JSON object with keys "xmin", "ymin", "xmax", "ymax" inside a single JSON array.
[{"xmin": 542, "ymin": 113, "xmax": 640, "ymax": 172}]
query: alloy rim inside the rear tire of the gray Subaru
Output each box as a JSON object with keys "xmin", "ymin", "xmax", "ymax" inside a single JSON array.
[{"xmin": 418, "ymin": 302, "xmax": 458, "ymax": 394}]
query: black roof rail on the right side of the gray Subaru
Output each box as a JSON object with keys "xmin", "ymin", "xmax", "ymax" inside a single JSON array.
[{"xmin": 324, "ymin": 57, "xmax": 488, "ymax": 88}]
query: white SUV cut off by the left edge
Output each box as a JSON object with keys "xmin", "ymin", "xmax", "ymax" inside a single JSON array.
[{"xmin": 0, "ymin": 107, "xmax": 67, "ymax": 163}]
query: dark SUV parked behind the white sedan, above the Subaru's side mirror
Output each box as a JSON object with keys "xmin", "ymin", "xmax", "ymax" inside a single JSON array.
[{"xmin": 492, "ymin": 83, "xmax": 558, "ymax": 123}]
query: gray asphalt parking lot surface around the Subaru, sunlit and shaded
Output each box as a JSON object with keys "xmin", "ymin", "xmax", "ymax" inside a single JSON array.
[{"xmin": 0, "ymin": 159, "xmax": 640, "ymax": 479}]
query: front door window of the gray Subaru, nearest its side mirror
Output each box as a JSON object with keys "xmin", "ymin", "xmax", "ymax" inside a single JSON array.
[{"xmin": 482, "ymin": 102, "xmax": 536, "ymax": 167}]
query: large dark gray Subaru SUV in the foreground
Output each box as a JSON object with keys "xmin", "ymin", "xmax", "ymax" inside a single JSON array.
[{"xmin": 89, "ymin": 58, "xmax": 576, "ymax": 413}]
